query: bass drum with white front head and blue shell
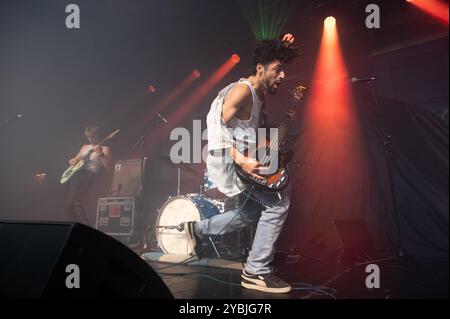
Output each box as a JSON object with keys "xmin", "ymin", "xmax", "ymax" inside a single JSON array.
[{"xmin": 156, "ymin": 194, "xmax": 220, "ymax": 255}]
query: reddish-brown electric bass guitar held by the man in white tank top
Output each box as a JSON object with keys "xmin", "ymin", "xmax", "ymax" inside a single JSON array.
[{"xmin": 235, "ymin": 85, "xmax": 306, "ymax": 192}]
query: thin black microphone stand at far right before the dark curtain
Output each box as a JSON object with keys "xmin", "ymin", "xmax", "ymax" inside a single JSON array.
[{"xmin": 367, "ymin": 81, "xmax": 404, "ymax": 259}]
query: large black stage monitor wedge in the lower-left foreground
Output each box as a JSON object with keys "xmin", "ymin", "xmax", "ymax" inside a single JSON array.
[{"xmin": 0, "ymin": 222, "xmax": 173, "ymax": 299}]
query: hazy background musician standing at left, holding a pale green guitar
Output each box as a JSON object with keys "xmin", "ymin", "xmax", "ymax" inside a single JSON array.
[{"xmin": 65, "ymin": 125, "xmax": 113, "ymax": 225}]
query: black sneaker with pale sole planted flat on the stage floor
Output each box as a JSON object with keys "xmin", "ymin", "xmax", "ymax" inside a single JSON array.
[{"xmin": 241, "ymin": 270, "xmax": 292, "ymax": 294}]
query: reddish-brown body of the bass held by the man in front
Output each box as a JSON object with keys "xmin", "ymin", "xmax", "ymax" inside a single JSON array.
[{"xmin": 235, "ymin": 139, "xmax": 289, "ymax": 192}]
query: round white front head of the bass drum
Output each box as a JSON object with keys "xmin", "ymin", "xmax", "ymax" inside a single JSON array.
[{"xmin": 156, "ymin": 196, "xmax": 201, "ymax": 255}]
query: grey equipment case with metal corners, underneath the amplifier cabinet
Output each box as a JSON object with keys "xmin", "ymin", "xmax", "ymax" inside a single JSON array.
[{"xmin": 95, "ymin": 196, "xmax": 150, "ymax": 244}]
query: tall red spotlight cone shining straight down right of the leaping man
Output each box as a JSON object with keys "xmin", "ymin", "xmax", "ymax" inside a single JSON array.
[{"xmin": 296, "ymin": 13, "xmax": 370, "ymax": 230}]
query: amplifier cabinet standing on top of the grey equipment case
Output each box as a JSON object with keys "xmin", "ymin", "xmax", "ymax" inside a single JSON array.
[{"xmin": 110, "ymin": 159, "xmax": 145, "ymax": 197}]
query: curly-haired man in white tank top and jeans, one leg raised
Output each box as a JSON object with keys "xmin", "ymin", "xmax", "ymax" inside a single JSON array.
[{"xmin": 183, "ymin": 40, "xmax": 298, "ymax": 293}]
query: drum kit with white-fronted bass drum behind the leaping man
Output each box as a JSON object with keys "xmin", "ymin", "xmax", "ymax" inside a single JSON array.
[{"xmin": 154, "ymin": 156, "xmax": 243, "ymax": 258}]
